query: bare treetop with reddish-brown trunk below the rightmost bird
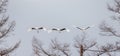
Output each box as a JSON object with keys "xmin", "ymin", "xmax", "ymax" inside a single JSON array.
[{"xmin": 74, "ymin": 31, "xmax": 97, "ymax": 56}]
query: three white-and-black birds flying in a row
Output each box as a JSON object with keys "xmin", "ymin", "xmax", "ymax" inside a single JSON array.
[{"xmin": 28, "ymin": 26, "xmax": 93, "ymax": 33}]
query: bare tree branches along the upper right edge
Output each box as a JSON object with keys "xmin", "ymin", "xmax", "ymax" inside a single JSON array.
[{"xmin": 99, "ymin": 0, "xmax": 120, "ymax": 37}]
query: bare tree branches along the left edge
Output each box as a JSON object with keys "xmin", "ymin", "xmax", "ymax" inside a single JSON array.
[{"xmin": 0, "ymin": 0, "xmax": 20, "ymax": 56}]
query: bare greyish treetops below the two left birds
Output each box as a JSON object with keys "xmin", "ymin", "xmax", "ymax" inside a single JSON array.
[{"xmin": 32, "ymin": 38, "xmax": 71, "ymax": 56}]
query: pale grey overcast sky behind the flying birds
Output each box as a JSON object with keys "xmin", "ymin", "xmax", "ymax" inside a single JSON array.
[{"xmin": 4, "ymin": 0, "xmax": 115, "ymax": 56}]
